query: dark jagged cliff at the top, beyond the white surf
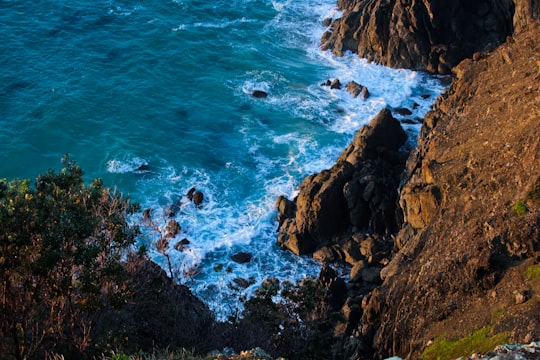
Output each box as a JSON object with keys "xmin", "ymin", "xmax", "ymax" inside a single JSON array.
[{"xmin": 321, "ymin": 0, "xmax": 540, "ymax": 74}]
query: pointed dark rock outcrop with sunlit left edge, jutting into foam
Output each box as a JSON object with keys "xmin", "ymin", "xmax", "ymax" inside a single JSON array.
[{"xmin": 277, "ymin": 109, "xmax": 407, "ymax": 255}]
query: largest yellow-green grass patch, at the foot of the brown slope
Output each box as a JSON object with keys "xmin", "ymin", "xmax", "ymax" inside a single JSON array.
[{"xmin": 422, "ymin": 326, "xmax": 510, "ymax": 360}]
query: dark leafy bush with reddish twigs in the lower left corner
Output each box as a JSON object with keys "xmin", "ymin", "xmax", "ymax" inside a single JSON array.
[{"xmin": 0, "ymin": 155, "xmax": 138, "ymax": 359}]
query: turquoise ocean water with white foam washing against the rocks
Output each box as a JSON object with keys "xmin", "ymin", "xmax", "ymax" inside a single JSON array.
[{"xmin": 0, "ymin": 0, "xmax": 443, "ymax": 318}]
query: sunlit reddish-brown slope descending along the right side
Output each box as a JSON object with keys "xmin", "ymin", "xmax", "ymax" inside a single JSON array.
[{"xmin": 363, "ymin": 22, "xmax": 540, "ymax": 358}]
